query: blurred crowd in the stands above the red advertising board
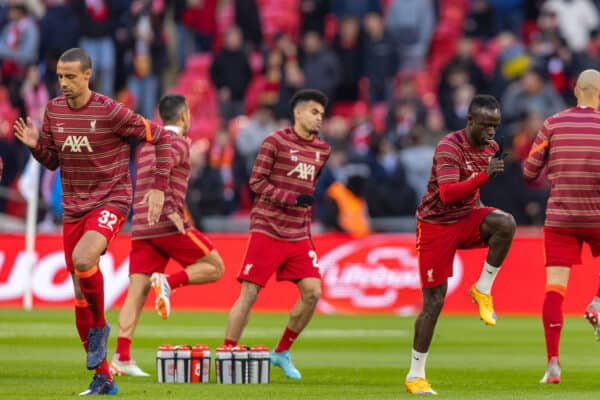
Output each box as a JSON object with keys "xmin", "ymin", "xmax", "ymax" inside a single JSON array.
[{"xmin": 0, "ymin": 0, "xmax": 600, "ymax": 236}]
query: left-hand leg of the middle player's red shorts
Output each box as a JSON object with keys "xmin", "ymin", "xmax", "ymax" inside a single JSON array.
[{"xmin": 237, "ymin": 232, "xmax": 287, "ymax": 287}]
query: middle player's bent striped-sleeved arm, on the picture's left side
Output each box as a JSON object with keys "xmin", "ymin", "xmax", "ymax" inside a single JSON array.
[{"xmin": 250, "ymin": 136, "xmax": 309, "ymax": 206}]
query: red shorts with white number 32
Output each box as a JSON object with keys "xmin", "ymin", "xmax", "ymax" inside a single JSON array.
[{"xmin": 63, "ymin": 207, "xmax": 125, "ymax": 272}]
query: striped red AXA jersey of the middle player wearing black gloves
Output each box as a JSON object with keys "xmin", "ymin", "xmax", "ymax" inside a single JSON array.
[{"xmin": 250, "ymin": 128, "xmax": 331, "ymax": 241}]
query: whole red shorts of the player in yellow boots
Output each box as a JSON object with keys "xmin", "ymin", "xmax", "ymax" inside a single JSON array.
[{"xmin": 417, "ymin": 207, "xmax": 496, "ymax": 288}]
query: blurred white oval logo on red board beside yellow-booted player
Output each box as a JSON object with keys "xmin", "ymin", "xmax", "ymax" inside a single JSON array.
[{"xmin": 318, "ymin": 235, "xmax": 463, "ymax": 314}]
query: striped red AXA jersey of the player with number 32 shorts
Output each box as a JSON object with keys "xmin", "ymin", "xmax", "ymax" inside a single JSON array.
[{"xmin": 31, "ymin": 92, "xmax": 172, "ymax": 223}]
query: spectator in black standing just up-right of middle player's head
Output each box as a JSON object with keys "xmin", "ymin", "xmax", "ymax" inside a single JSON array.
[{"xmin": 333, "ymin": 16, "xmax": 364, "ymax": 102}]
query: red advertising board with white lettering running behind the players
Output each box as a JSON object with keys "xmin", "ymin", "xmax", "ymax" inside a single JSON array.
[{"xmin": 0, "ymin": 234, "xmax": 600, "ymax": 314}]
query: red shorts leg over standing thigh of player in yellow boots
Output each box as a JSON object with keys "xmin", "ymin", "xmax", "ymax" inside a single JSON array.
[{"xmin": 417, "ymin": 221, "xmax": 459, "ymax": 288}]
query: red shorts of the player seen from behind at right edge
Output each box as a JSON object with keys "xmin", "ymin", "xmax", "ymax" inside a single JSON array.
[{"xmin": 544, "ymin": 226, "xmax": 600, "ymax": 267}]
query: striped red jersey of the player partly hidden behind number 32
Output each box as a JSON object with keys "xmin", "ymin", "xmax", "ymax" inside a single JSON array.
[{"xmin": 131, "ymin": 127, "xmax": 191, "ymax": 240}]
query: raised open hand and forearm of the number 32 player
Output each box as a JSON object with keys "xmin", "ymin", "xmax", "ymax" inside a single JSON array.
[{"xmin": 13, "ymin": 110, "xmax": 59, "ymax": 171}]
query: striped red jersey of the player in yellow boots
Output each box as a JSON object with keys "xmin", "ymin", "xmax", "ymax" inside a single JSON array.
[{"xmin": 417, "ymin": 129, "xmax": 499, "ymax": 224}]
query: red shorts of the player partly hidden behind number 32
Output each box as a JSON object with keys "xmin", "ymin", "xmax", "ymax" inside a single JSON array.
[{"xmin": 129, "ymin": 228, "xmax": 215, "ymax": 275}]
